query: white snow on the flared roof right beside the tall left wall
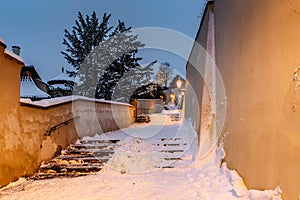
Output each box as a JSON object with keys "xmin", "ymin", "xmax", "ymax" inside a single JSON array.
[{"xmin": 20, "ymin": 77, "xmax": 51, "ymax": 98}]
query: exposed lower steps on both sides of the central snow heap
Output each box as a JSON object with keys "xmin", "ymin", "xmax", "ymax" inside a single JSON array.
[{"xmin": 31, "ymin": 135, "xmax": 192, "ymax": 179}]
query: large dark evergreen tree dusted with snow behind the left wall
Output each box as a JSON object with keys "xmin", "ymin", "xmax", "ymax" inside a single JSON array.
[{"xmin": 62, "ymin": 12, "xmax": 148, "ymax": 100}]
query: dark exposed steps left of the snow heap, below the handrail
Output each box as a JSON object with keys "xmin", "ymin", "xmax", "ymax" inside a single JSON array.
[{"xmin": 31, "ymin": 140, "xmax": 119, "ymax": 179}]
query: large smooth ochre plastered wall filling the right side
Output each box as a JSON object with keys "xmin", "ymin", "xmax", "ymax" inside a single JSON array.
[{"xmin": 215, "ymin": 0, "xmax": 300, "ymax": 200}]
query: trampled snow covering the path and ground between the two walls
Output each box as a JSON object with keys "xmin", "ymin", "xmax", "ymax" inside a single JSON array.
[{"xmin": 0, "ymin": 111, "xmax": 281, "ymax": 200}]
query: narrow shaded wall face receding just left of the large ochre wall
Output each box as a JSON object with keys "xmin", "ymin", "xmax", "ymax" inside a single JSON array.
[{"xmin": 185, "ymin": 3, "xmax": 213, "ymax": 144}]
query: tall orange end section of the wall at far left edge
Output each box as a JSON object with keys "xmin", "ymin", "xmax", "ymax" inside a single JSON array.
[{"xmin": 0, "ymin": 38, "xmax": 24, "ymax": 186}]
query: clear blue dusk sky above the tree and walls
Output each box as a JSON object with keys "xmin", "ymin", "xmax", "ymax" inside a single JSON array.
[{"xmin": 0, "ymin": 0, "xmax": 204, "ymax": 81}]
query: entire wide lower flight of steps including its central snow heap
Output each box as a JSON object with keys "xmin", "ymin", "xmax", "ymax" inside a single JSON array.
[{"xmin": 34, "ymin": 128, "xmax": 189, "ymax": 179}]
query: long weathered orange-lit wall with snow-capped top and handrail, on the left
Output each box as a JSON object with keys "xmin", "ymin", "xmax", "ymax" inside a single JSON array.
[{"xmin": 0, "ymin": 38, "xmax": 135, "ymax": 187}]
